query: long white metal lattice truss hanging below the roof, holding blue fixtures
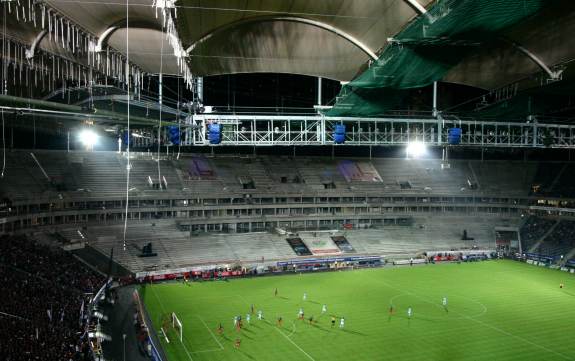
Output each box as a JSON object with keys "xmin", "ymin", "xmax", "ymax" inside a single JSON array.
[{"xmin": 182, "ymin": 114, "xmax": 575, "ymax": 149}]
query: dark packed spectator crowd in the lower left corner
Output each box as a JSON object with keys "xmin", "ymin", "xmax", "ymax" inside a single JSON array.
[{"xmin": 0, "ymin": 236, "xmax": 105, "ymax": 361}]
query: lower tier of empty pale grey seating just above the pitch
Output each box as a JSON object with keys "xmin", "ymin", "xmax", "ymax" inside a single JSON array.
[{"xmin": 67, "ymin": 217, "xmax": 513, "ymax": 271}]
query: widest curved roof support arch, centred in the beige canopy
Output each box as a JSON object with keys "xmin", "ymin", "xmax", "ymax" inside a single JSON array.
[{"xmin": 186, "ymin": 16, "xmax": 378, "ymax": 60}]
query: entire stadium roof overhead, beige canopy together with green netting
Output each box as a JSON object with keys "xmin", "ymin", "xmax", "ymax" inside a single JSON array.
[{"xmin": 4, "ymin": 0, "xmax": 575, "ymax": 121}]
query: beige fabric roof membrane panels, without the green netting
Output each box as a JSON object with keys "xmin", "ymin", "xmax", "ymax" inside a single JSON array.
[{"xmin": 20, "ymin": 0, "xmax": 575, "ymax": 85}]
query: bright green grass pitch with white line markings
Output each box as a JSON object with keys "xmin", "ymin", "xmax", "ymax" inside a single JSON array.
[{"xmin": 140, "ymin": 261, "xmax": 575, "ymax": 361}]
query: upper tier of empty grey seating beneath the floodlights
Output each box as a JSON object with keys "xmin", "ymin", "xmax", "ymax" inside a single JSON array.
[{"xmin": 2, "ymin": 151, "xmax": 564, "ymax": 200}]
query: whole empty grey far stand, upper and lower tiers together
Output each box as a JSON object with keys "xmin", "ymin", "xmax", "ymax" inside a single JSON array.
[{"xmin": 0, "ymin": 147, "xmax": 570, "ymax": 272}]
